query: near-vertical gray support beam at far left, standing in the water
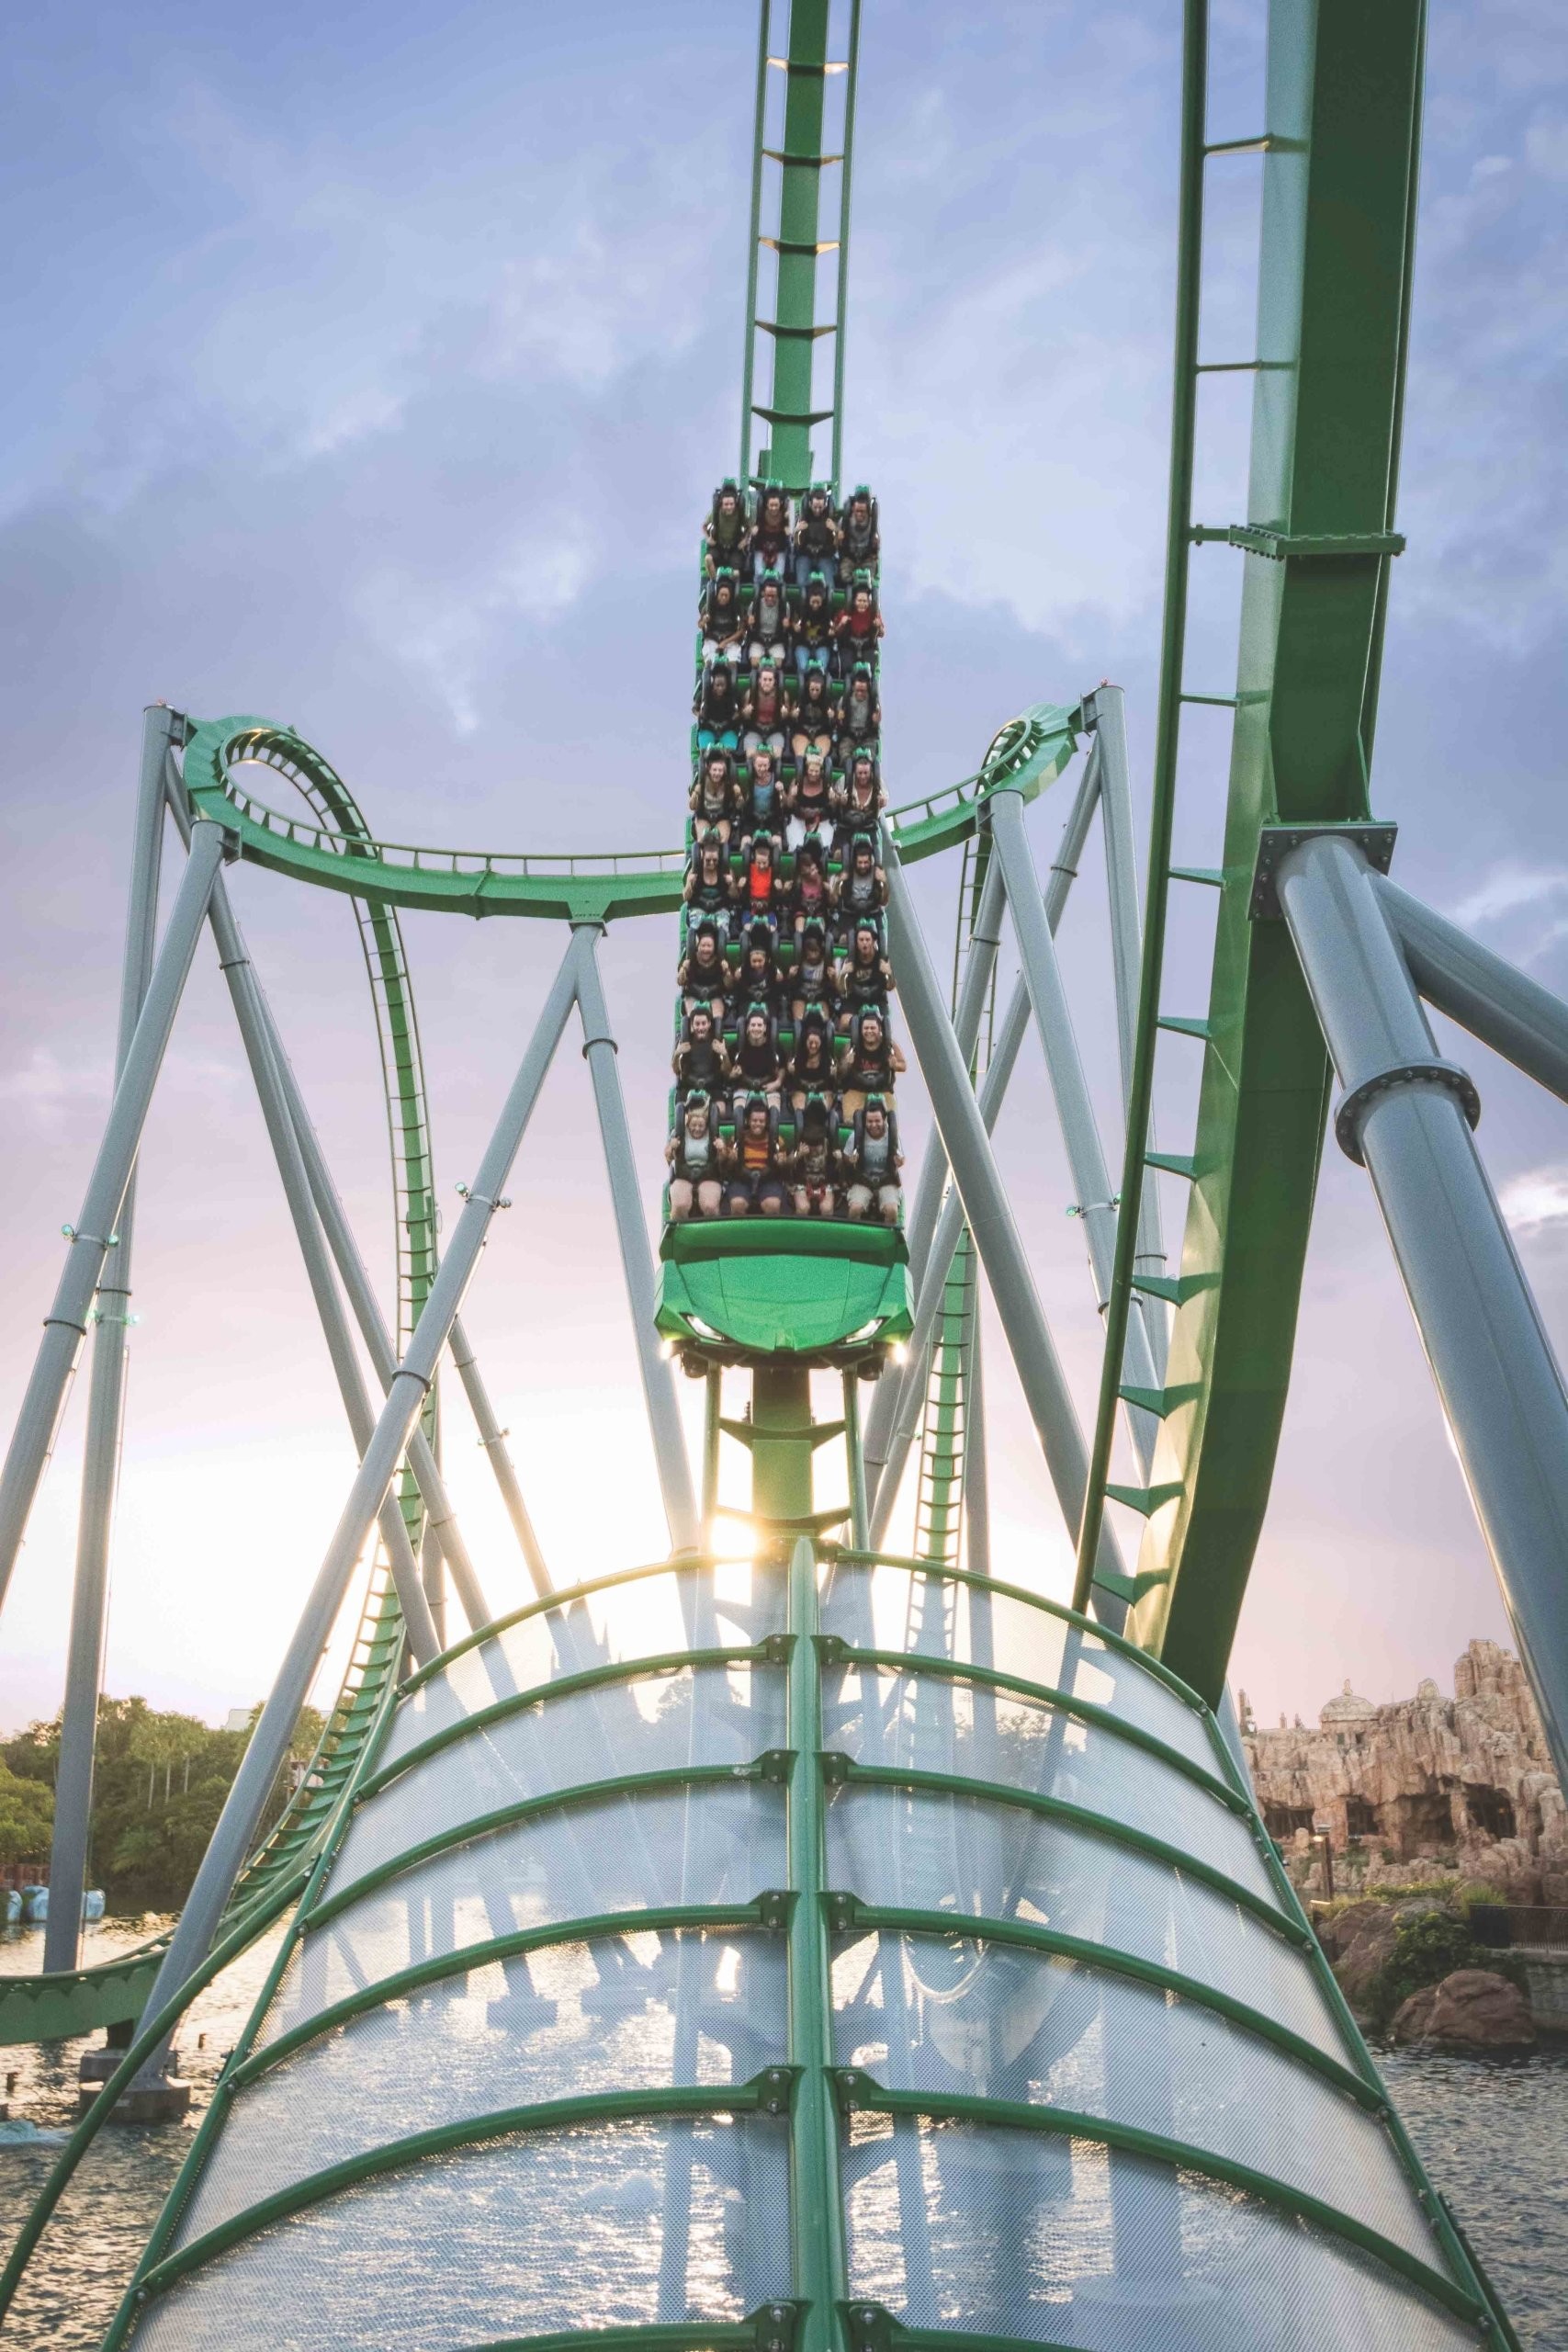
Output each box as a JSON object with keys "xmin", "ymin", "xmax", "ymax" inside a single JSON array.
[{"xmin": 45, "ymin": 703, "xmax": 179, "ymax": 1971}]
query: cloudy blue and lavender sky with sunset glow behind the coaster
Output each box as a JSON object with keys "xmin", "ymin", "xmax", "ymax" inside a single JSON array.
[{"xmin": 0, "ymin": 0, "xmax": 1568, "ymax": 1726}]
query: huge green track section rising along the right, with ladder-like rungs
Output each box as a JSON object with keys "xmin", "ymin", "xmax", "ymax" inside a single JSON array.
[{"xmin": 1077, "ymin": 0, "xmax": 1425, "ymax": 1701}]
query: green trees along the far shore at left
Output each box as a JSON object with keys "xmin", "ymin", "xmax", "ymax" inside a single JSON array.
[{"xmin": 0, "ymin": 1698, "xmax": 322, "ymax": 1912}]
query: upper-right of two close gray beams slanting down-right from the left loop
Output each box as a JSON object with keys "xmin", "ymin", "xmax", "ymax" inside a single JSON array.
[{"xmin": 164, "ymin": 774, "xmax": 491, "ymax": 1630}]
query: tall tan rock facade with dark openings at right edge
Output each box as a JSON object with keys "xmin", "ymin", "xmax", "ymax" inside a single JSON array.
[{"xmin": 1239, "ymin": 1642, "xmax": 1568, "ymax": 1905}]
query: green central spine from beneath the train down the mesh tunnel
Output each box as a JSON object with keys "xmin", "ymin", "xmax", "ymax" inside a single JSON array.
[{"xmin": 752, "ymin": 1364, "xmax": 846, "ymax": 2352}]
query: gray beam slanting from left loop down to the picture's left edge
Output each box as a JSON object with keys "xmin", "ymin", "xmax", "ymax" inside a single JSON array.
[{"xmin": 0, "ymin": 820, "xmax": 223, "ymax": 1601}]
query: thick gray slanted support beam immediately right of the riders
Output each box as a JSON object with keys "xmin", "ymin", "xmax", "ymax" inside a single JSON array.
[{"xmin": 886, "ymin": 847, "xmax": 1123, "ymax": 1609}]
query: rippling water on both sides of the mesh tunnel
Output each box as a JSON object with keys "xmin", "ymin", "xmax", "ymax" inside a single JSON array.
[{"xmin": 0, "ymin": 1924, "xmax": 1568, "ymax": 2352}]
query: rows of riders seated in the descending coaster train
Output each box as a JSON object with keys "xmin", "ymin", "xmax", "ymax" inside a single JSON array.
[{"xmin": 665, "ymin": 480, "xmax": 905, "ymax": 1223}]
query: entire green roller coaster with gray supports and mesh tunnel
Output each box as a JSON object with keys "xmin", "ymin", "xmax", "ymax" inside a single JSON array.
[{"xmin": 0, "ymin": 0, "xmax": 1568, "ymax": 2352}]
